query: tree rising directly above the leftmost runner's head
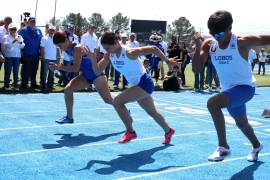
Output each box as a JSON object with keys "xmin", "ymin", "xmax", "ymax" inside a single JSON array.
[{"xmin": 62, "ymin": 13, "xmax": 89, "ymax": 34}]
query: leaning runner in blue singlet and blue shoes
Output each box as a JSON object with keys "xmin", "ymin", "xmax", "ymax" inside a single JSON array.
[{"xmin": 49, "ymin": 31, "xmax": 113, "ymax": 124}]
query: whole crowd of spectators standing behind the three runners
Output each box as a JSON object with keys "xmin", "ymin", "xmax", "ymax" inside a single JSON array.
[{"xmin": 0, "ymin": 17, "xmax": 267, "ymax": 92}]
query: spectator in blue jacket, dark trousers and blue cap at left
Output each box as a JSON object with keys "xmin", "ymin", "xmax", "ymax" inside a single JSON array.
[{"xmin": 20, "ymin": 17, "xmax": 42, "ymax": 89}]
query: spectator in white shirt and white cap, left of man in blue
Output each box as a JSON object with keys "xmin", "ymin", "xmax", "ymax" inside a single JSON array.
[{"xmin": 2, "ymin": 24, "xmax": 25, "ymax": 90}]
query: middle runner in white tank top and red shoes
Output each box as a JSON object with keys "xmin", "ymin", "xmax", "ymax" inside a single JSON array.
[{"xmin": 89, "ymin": 32, "xmax": 175, "ymax": 144}]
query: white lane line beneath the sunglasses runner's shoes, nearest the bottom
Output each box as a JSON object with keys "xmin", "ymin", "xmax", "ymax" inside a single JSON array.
[{"xmin": 116, "ymin": 152, "xmax": 270, "ymax": 180}]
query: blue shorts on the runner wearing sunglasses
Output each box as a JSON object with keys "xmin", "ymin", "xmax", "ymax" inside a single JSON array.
[{"xmin": 223, "ymin": 85, "xmax": 255, "ymax": 117}]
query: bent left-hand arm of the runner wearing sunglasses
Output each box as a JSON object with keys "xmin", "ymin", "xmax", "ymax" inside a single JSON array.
[{"xmin": 192, "ymin": 33, "xmax": 210, "ymax": 74}]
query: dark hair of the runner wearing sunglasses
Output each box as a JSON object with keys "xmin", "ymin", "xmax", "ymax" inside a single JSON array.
[{"xmin": 207, "ymin": 10, "xmax": 233, "ymax": 34}]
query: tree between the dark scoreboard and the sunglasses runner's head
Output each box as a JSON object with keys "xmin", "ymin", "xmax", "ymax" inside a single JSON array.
[{"xmin": 167, "ymin": 17, "xmax": 195, "ymax": 44}]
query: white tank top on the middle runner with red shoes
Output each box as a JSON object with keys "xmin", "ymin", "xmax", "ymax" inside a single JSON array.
[{"xmin": 110, "ymin": 46, "xmax": 146, "ymax": 85}]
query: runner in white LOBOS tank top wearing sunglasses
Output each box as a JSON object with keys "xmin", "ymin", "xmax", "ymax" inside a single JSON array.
[{"xmin": 192, "ymin": 11, "xmax": 270, "ymax": 162}]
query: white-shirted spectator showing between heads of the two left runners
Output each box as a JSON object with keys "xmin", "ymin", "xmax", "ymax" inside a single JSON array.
[{"xmin": 81, "ymin": 25, "xmax": 98, "ymax": 52}]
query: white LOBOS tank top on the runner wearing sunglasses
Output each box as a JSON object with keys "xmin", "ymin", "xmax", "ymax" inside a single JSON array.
[{"xmin": 209, "ymin": 34, "xmax": 256, "ymax": 91}]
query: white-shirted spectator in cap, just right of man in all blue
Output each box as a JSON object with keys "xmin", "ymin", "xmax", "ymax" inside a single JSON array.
[{"xmin": 40, "ymin": 25, "xmax": 57, "ymax": 90}]
